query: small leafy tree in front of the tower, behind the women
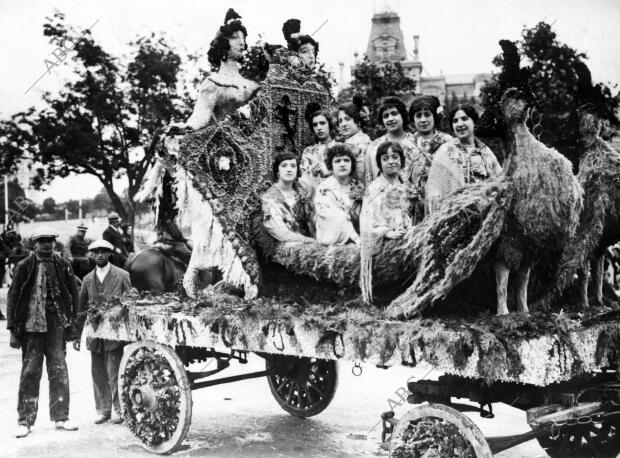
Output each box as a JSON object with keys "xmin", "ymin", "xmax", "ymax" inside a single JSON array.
[{"xmin": 338, "ymin": 57, "xmax": 416, "ymax": 137}]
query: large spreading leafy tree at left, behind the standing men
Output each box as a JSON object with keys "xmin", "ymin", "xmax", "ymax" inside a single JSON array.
[{"xmin": 0, "ymin": 12, "xmax": 191, "ymax": 221}]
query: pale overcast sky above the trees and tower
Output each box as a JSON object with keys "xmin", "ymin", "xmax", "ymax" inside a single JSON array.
[{"xmin": 0, "ymin": 0, "xmax": 620, "ymax": 201}]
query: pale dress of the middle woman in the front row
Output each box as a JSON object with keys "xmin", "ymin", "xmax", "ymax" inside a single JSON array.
[{"xmin": 314, "ymin": 176, "xmax": 360, "ymax": 245}]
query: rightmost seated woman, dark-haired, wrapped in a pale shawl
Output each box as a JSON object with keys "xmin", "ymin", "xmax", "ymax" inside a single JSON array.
[{"xmin": 426, "ymin": 105, "xmax": 502, "ymax": 213}]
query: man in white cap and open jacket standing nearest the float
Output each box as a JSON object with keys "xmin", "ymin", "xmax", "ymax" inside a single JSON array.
[{"xmin": 73, "ymin": 240, "xmax": 131, "ymax": 424}]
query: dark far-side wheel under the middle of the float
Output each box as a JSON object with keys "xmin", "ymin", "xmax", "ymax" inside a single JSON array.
[{"xmin": 266, "ymin": 355, "xmax": 338, "ymax": 418}]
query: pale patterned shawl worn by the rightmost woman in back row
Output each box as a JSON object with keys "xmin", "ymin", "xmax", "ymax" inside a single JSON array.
[{"xmin": 426, "ymin": 138, "xmax": 502, "ymax": 213}]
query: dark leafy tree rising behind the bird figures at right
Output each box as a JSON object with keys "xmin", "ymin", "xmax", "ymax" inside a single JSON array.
[{"xmin": 479, "ymin": 22, "xmax": 618, "ymax": 164}]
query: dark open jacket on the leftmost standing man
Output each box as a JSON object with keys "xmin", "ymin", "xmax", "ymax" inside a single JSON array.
[{"xmin": 6, "ymin": 253, "xmax": 78, "ymax": 336}]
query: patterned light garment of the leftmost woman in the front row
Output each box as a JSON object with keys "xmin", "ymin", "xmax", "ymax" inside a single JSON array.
[{"xmin": 261, "ymin": 183, "xmax": 314, "ymax": 242}]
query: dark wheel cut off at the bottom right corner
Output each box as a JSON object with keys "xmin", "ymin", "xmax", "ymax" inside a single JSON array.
[{"xmin": 538, "ymin": 419, "xmax": 620, "ymax": 458}]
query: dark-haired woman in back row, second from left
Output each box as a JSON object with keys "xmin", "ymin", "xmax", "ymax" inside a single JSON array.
[{"xmin": 338, "ymin": 97, "xmax": 371, "ymax": 182}]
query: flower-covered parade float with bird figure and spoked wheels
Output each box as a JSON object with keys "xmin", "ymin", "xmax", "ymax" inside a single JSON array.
[{"xmin": 86, "ymin": 12, "xmax": 620, "ymax": 457}]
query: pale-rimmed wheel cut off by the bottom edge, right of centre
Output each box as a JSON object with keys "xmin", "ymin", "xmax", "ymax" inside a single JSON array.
[{"xmin": 390, "ymin": 404, "xmax": 493, "ymax": 458}]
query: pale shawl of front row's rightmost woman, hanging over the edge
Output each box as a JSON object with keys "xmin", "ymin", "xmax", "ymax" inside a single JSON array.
[{"xmin": 360, "ymin": 175, "xmax": 414, "ymax": 302}]
